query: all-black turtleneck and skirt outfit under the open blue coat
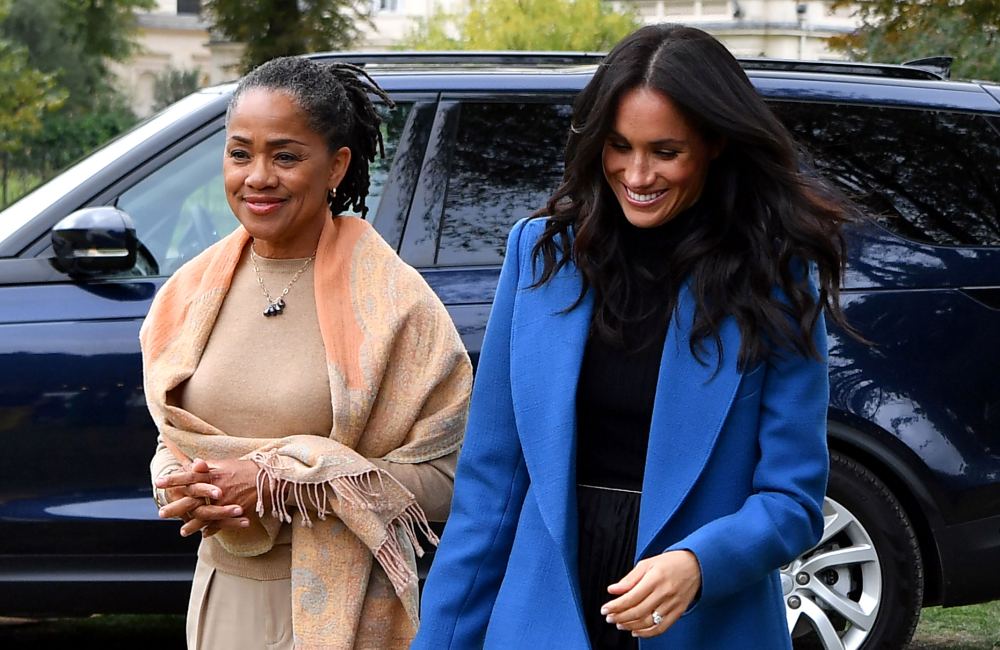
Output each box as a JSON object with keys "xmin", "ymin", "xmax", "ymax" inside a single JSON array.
[{"xmin": 576, "ymin": 223, "xmax": 678, "ymax": 650}]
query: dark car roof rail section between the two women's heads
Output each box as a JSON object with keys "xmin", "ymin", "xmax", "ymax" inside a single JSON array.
[{"xmin": 309, "ymin": 51, "xmax": 605, "ymax": 66}]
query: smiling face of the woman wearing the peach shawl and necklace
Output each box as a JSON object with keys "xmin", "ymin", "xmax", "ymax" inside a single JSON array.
[{"xmin": 222, "ymin": 88, "xmax": 351, "ymax": 258}]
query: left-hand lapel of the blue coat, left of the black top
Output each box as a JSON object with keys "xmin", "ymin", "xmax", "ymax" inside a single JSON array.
[{"xmin": 511, "ymin": 265, "xmax": 593, "ymax": 584}]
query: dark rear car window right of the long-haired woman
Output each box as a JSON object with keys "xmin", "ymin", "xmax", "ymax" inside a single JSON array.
[{"xmin": 773, "ymin": 102, "xmax": 1000, "ymax": 246}]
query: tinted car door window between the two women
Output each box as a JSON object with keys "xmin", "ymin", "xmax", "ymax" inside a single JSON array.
[{"xmin": 437, "ymin": 102, "xmax": 572, "ymax": 266}]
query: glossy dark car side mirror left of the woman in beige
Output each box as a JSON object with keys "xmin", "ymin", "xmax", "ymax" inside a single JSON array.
[{"xmin": 52, "ymin": 205, "xmax": 138, "ymax": 278}]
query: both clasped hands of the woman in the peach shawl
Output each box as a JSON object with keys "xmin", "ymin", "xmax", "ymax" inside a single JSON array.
[{"xmin": 155, "ymin": 458, "xmax": 258, "ymax": 537}]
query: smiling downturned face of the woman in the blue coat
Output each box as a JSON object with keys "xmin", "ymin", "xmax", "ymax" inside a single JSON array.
[{"xmin": 602, "ymin": 87, "xmax": 721, "ymax": 228}]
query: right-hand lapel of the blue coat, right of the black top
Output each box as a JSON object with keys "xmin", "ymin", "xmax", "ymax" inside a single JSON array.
[{"xmin": 636, "ymin": 283, "xmax": 741, "ymax": 560}]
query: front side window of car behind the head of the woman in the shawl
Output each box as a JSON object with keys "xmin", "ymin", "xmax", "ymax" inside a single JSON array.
[{"xmin": 116, "ymin": 104, "xmax": 411, "ymax": 276}]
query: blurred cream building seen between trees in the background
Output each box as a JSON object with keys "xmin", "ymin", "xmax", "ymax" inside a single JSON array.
[{"xmin": 115, "ymin": 0, "xmax": 857, "ymax": 115}]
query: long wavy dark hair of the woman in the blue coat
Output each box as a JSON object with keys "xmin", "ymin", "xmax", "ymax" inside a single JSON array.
[{"xmin": 533, "ymin": 25, "xmax": 853, "ymax": 369}]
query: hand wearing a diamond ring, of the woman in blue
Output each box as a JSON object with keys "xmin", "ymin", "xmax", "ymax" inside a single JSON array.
[{"xmin": 601, "ymin": 551, "xmax": 701, "ymax": 639}]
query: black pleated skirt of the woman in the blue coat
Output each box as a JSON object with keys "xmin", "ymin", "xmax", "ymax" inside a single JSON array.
[{"xmin": 576, "ymin": 485, "xmax": 641, "ymax": 650}]
